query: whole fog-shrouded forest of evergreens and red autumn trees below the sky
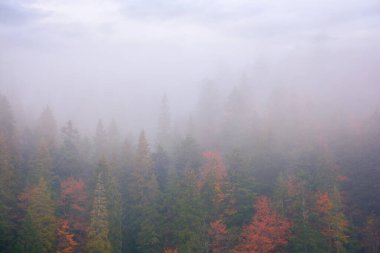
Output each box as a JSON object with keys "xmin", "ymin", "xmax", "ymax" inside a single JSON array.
[{"xmin": 0, "ymin": 81, "xmax": 380, "ymax": 253}]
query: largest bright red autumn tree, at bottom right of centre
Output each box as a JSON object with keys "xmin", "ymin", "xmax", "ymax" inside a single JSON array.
[{"xmin": 235, "ymin": 197, "xmax": 291, "ymax": 253}]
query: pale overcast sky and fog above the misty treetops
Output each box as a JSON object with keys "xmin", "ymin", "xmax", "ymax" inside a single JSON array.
[{"xmin": 0, "ymin": 0, "xmax": 380, "ymax": 133}]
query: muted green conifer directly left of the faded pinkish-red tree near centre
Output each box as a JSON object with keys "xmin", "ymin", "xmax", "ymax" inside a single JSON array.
[{"xmin": 163, "ymin": 168, "xmax": 208, "ymax": 253}]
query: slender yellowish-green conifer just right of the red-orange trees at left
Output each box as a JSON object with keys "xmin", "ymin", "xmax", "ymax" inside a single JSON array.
[{"xmin": 87, "ymin": 161, "xmax": 112, "ymax": 253}]
